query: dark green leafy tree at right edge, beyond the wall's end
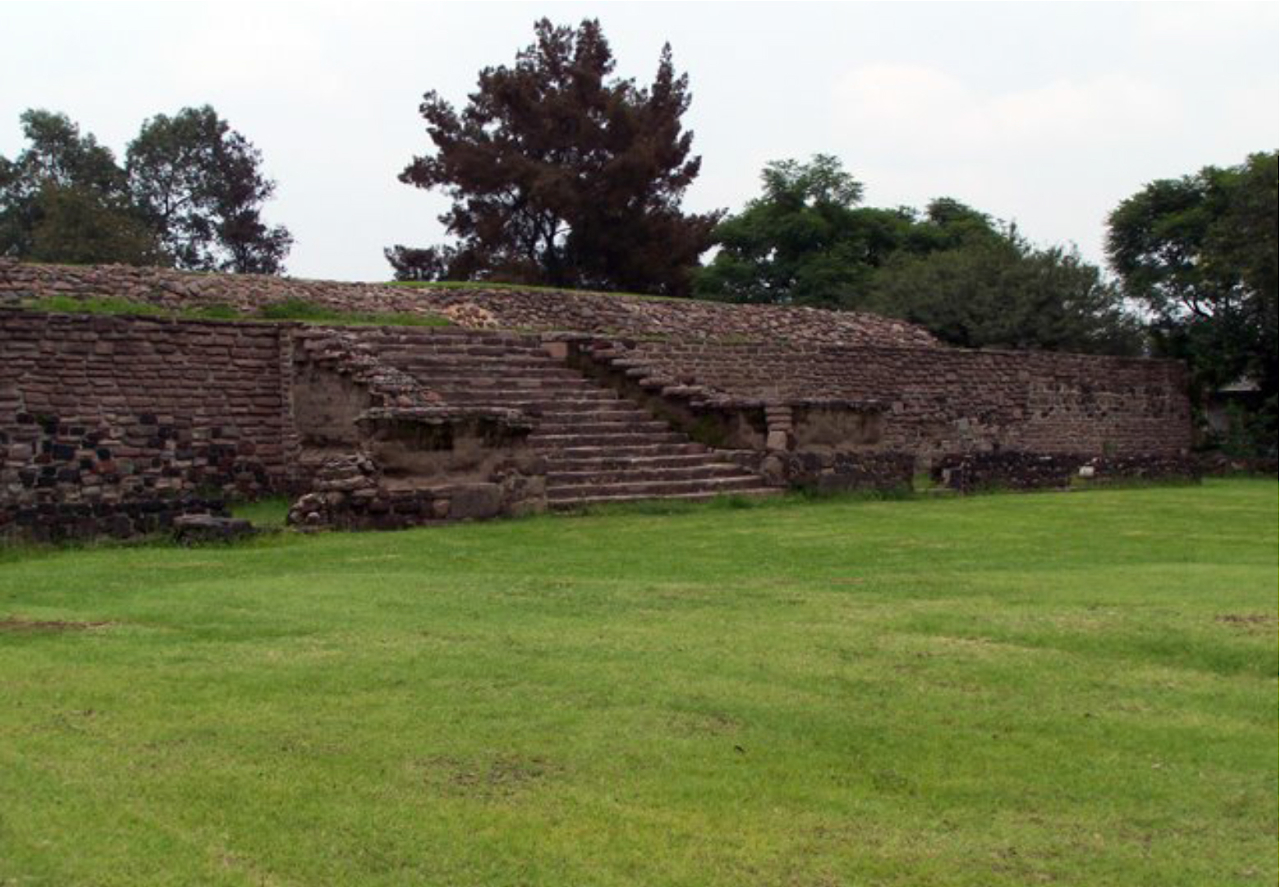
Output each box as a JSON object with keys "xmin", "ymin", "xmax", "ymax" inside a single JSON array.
[{"xmin": 1107, "ymin": 151, "xmax": 1280, "ymax": 453}]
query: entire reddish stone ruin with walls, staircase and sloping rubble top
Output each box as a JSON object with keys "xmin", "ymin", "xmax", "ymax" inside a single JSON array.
[{"xmin": 0, "ymin": 260, "xmax": 1193, "ymax": 540}]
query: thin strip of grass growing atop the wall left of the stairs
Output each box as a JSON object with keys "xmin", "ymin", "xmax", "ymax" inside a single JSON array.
[{"xmin": 22, "ymin": 296, "xmax": 451, "ymax": 326}]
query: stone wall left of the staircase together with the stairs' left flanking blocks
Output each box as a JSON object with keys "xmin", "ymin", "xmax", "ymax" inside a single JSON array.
[{"xmin": 0, "ymin": 308, "xmax": 558, "ymax": 540}]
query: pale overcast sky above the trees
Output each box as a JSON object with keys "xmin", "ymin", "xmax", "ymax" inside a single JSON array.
[{"xmin": 0, "ymin": 1, "xmax": 1280, "ymax": 280}]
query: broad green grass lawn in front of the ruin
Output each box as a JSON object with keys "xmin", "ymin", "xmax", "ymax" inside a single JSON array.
[{"xmin": 0, "ymin": 480, "xmax": 1277, "ymax": 887}]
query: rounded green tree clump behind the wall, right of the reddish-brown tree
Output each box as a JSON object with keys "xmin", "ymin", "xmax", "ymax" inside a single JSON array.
[{"xmin": 696, "ymin": 155, "xmax": 1142, "ymax": 353}]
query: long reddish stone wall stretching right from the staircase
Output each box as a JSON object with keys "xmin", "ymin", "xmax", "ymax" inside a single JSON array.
[{"xmin": 577, "ymin": 340, "xmax": 1192, "ymax": 463}]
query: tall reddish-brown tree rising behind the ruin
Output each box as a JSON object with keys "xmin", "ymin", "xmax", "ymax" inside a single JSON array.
[{"xmin": 388, "ymin": 19, "xmax": 719, "ymax": 296}]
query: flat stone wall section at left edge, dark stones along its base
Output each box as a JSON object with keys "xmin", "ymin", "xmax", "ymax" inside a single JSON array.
[{"xmin": 0, "ymin": 310, "xmax": 291, "ymax": 540}]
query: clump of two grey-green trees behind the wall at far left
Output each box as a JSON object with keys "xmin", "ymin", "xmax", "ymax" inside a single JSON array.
[{"xmin": 0, "ymin": 106, "xmax": 292, "ymax": 274}]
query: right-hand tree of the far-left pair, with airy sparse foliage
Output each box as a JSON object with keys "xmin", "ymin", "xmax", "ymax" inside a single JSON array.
[{"xmin": 127, "ymin": 105, "xmax": 293, "ymax": 274}]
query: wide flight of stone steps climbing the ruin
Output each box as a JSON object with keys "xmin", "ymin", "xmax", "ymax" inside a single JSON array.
[{"xmin": 367, "ymin": 330, "xmax": 778, "ymax": 509}]
